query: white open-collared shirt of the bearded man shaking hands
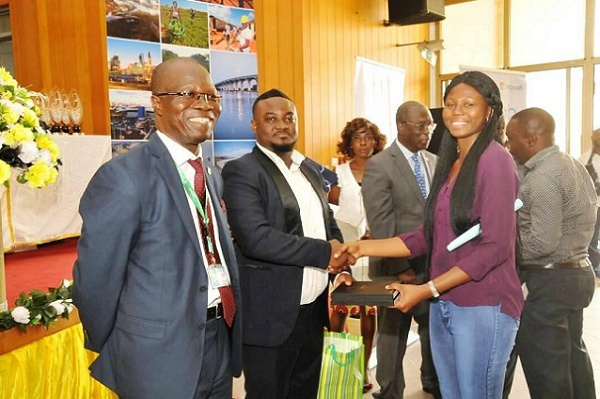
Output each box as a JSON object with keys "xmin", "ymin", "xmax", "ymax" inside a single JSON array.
[{"xmin": 256, "ymin": 143, "xmax": 329, "ymax": 305}]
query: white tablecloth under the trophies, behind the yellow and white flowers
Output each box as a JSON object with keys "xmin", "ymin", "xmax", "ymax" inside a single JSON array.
[{"xmin": 1, "ymin": 136, "xmax": 111, "ymax": 251}]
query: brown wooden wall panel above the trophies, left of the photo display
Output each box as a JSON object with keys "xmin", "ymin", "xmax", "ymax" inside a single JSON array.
[{"xmin": 9, "ymin": 0, "xmax": 110, "ymax": 134}]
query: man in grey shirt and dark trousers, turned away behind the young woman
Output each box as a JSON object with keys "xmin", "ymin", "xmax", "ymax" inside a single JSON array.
[{"xmin": 506, "ymin": 108, "xmax": 597, "ymax": 399}]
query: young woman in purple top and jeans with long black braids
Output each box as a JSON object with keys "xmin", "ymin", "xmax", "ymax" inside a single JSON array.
[{"xmin": 336, "ymin": 71, "xmax": 523, "ymax": 399}]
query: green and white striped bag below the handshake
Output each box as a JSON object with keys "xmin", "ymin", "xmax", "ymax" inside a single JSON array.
[{"xmin": 317, "ymin": 331, "xmax": 365, "ymax": 399}]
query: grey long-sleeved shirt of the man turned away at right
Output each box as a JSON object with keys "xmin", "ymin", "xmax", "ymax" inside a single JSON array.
[{"xmin": 519, "ymin": 146, "xmax": 597, "ymax": 265}]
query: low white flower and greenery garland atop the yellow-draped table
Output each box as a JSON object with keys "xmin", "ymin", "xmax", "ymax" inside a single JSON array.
[{"xmin": 0, "ymin": 280, "xmax": 74, "ymax": 332}]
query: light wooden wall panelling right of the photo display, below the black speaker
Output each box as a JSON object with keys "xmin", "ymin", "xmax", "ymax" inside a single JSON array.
[{"xmin": 254, "ymin": 0, "xmax": 430, "ymax": 165}]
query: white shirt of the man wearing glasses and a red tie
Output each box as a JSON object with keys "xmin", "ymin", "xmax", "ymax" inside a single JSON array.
[{"xmin": 156, "ymin": 131, "xmax": 229, "ymax": 307}]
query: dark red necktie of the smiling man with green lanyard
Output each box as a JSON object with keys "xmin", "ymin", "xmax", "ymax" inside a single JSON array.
[{"xmin": 188, "ymin": 158, "xmax": 236, "ymax": 327}]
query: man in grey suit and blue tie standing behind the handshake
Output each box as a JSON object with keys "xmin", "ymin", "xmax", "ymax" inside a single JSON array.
[{"xmin": 362, "ymin": 101, "xmax": 441, "ymax": 399}]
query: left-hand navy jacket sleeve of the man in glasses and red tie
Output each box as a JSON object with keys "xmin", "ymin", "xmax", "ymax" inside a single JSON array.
[{"xmin": 73, "ymin": 164, "xmax": 140, "ymax": 352}]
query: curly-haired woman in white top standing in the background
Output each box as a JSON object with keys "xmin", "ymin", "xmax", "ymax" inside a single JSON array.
[{"xmin": 329, "ymin": 118, "xmax": 385, "ymax": 392}]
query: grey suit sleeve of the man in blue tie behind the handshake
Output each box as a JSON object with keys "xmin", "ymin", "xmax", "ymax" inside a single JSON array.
[{"xmin": 361, "ymin": 152, "xmax": 410, "ymax": 278}]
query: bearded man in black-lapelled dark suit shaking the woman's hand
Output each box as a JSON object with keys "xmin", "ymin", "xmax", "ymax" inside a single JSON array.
[{"xmin": 223, "ymin": 89, "xmax": 350, "ymax": 399}]
